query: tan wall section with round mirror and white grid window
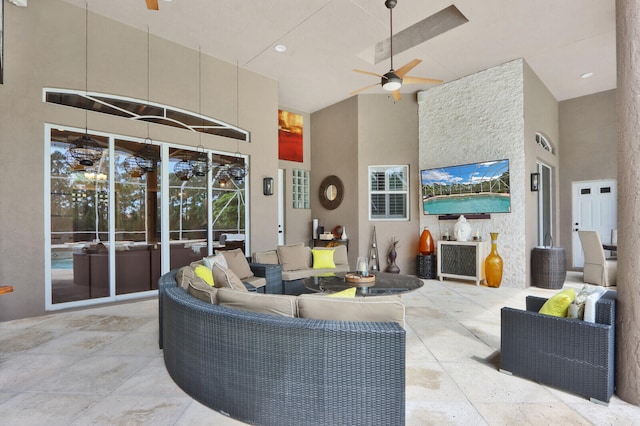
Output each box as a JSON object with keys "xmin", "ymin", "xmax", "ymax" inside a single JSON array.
[{"xmin": 311, "ymin": 94, "xmax": 420, "ymax": 274}]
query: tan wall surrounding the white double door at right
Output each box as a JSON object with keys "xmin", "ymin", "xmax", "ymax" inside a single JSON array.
[{"xmin": 559, "ymin": 90, "xmax": 618, "ymax": 268}]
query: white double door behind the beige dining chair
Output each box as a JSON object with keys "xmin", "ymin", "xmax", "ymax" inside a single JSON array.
[{"xmin": 571, "ymin": 179, "xmax": 618, "ymax": 268}]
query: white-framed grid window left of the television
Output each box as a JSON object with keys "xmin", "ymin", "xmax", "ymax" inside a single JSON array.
[{"xmin": 369, "ymin": 166, "xmax": 409, "ymax": 220}]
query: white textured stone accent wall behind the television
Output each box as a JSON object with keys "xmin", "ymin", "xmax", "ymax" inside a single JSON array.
[{"xmin": 418, "ymin": 59, "xmax": 529, "ymax": 288}]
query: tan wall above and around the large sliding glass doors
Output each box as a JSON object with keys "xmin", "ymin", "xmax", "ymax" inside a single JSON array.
[{"xmin": 0, "ymin": 0, "xmax": 278, "ymax": 320}]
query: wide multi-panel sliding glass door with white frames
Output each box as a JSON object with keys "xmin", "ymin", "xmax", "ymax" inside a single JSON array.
[{"xmin": 45, "ymin": 126, "xmax": 248, "ymax": 309}]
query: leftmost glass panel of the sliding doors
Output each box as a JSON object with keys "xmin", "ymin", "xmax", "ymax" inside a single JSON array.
[{"xmin": 50, "ymin": 130, "xmax": 109, "ymax": 304}]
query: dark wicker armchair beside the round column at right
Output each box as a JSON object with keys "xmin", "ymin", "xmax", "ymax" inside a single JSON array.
[{"xmin": 500, "ymin": 291, "xmax": 616, "ymax": 404}]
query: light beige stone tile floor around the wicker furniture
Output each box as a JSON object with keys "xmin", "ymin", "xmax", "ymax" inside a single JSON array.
[{"xmin": 0, "ymin": 273, "xmax": 640, "ymax": 426}]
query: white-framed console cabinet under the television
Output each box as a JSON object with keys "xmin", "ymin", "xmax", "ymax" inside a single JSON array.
[{"xmin": 437, "ymin": 241, "xmax": 489, "ymax": 285}]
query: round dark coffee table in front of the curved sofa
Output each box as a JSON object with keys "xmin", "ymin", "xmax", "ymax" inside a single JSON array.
[{"xmin": 303, "ymin": 272, "xmax": 424, "ymax": 296}]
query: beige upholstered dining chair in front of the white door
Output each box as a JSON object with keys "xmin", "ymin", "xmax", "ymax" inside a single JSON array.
[{"xmin": 578, "ymin": 231, "xmax": 618, "ymax": 287}]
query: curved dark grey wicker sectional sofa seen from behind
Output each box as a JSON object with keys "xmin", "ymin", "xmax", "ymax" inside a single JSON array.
[{"xmin": 159, "ymin": 270, "xmax": 406, "ymax": 426}]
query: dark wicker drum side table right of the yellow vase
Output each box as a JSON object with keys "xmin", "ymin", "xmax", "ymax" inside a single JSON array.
[{"xmin": 531, "ymin": 247, "xmax": 567, "ymax": 289}]
